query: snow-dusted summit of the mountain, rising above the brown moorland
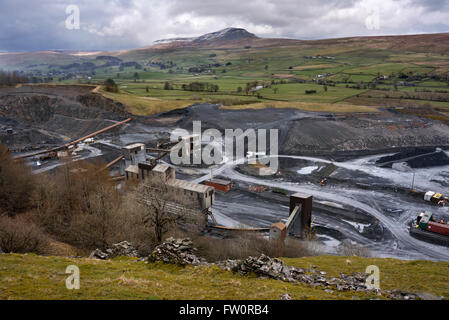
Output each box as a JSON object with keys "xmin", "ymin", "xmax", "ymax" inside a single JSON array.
[{"xmin": 154, "ymin": 28, "xmax": 257, "ymax": 44}]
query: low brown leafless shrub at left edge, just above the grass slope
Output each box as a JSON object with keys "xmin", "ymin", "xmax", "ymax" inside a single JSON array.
[{"xmin": 0, "ymin": 216, "xmax": 48, "ymax": 253}]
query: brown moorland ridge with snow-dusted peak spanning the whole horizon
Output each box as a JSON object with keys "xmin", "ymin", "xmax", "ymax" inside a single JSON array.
[{"xmin": 0, "ymin": 28, "xmax": 449, "ymax": 70}]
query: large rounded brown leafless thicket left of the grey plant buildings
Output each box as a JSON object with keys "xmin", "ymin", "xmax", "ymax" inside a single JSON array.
[{"xmin": 34, "ymin": 163, "xmax": 120, "ymax": 249}]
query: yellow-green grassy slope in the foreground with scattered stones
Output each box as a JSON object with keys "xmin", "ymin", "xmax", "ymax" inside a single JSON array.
[{"xmin": 0, "ymin": 254, "xmax": 449, "ymax": 300}]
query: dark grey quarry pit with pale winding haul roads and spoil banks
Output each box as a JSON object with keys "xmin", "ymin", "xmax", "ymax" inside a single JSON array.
[{"xmin": 0, "ymin": 86, "xmax": 449, "ymax": 260}]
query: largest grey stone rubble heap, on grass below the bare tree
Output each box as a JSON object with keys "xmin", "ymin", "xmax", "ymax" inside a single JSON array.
[{"xmin": 148, "ymin": 238, "xmax": 209, "ymax": 266}]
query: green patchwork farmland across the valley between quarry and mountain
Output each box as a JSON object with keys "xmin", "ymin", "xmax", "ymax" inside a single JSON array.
[{"xmin": 0, "ymin": 35, "xmax": 449, "ymax": 115}]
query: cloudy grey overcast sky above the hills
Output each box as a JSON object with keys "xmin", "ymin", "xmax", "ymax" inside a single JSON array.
[{"xmin": 0, "ymin": 0, "xmax": 449, "ymax": 51}]
